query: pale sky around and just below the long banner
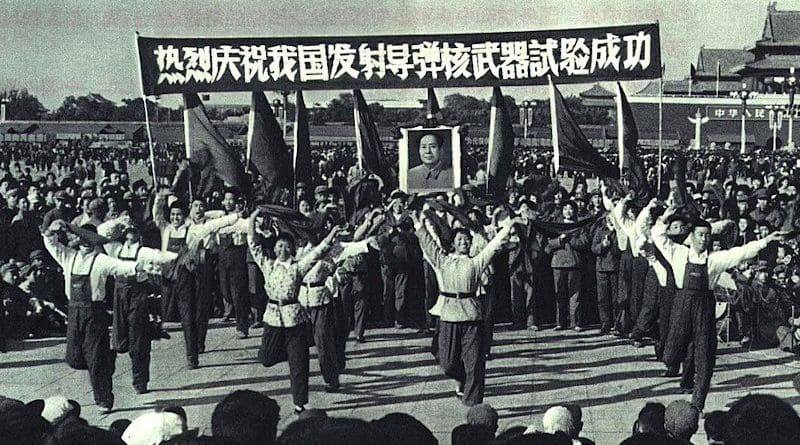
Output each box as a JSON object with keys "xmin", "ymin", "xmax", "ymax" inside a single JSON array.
[{"xmin": 0, "ymin": 0, "xmax": 800, "ymax": 109}]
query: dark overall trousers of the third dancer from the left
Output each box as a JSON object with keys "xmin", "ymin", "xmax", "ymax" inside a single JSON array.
[{"xmin": 173, "ymin": 265, "xmax": 211, "ymax": 365}]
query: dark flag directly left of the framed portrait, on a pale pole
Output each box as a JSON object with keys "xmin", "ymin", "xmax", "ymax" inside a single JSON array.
[{"xmin": 353, "ymin": 90, "xmax": 398, "ymax": 190}]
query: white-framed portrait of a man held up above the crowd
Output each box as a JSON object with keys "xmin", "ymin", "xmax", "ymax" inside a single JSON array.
[{"xmin": 398, "ymin": 126, "xmax": 461, "ymax": 194}]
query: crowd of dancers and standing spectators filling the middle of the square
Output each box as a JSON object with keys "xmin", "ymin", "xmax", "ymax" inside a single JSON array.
[{"xmin": 0, "ymin": 138, "xmax": 800, "ymax": 443}]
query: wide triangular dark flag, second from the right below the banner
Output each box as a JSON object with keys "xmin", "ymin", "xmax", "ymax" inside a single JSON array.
[{"xmin": 550, "ymin": 79, "xmax": 619, "ymax": 179}]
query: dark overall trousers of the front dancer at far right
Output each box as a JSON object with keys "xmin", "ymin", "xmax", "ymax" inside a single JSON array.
[{"xmin": 664, "ymin": 290, "xmax": 717, "ymax": 410}]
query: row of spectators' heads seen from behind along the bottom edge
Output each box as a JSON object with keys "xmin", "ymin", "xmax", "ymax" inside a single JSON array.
[{"xmin": 0, "ymin": 390, "xmax": 800, "ymax": 445}]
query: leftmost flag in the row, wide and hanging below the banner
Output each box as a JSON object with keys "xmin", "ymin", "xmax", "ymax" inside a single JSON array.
[{"xmin": 183, "ymin": 93, "xmax": 250, "ymax": 193}]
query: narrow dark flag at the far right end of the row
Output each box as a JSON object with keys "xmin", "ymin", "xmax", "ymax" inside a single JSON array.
[{"xmin": 616, "ymin": 82, "xmax": 651, "ymax": 207}]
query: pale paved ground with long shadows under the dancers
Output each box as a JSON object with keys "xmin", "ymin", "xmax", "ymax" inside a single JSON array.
[{"xmin": 0, "ymin": 322, "xmax": 800, "ymax": 444}]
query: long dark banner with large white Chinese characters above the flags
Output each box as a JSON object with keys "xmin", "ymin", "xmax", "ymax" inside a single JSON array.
[{"xmin": 137, "ymin": 24, "xmax": 661, "ymax": 95}]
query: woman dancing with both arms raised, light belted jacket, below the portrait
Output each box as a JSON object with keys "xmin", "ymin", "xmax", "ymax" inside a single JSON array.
[{"xmin": 410, "ymin": 212, "xmax": 518, "ymax": 406}]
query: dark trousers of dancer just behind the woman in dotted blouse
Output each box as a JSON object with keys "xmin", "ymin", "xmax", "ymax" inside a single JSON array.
[{"xmin": 308, "ymin": 303, "xmax": 342, "ymax": 385}]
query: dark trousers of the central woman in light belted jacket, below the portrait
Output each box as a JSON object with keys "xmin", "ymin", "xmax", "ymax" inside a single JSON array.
[{"xmin": 438, "ymin": 320, "xmax": 486, "ymax": 406}]
